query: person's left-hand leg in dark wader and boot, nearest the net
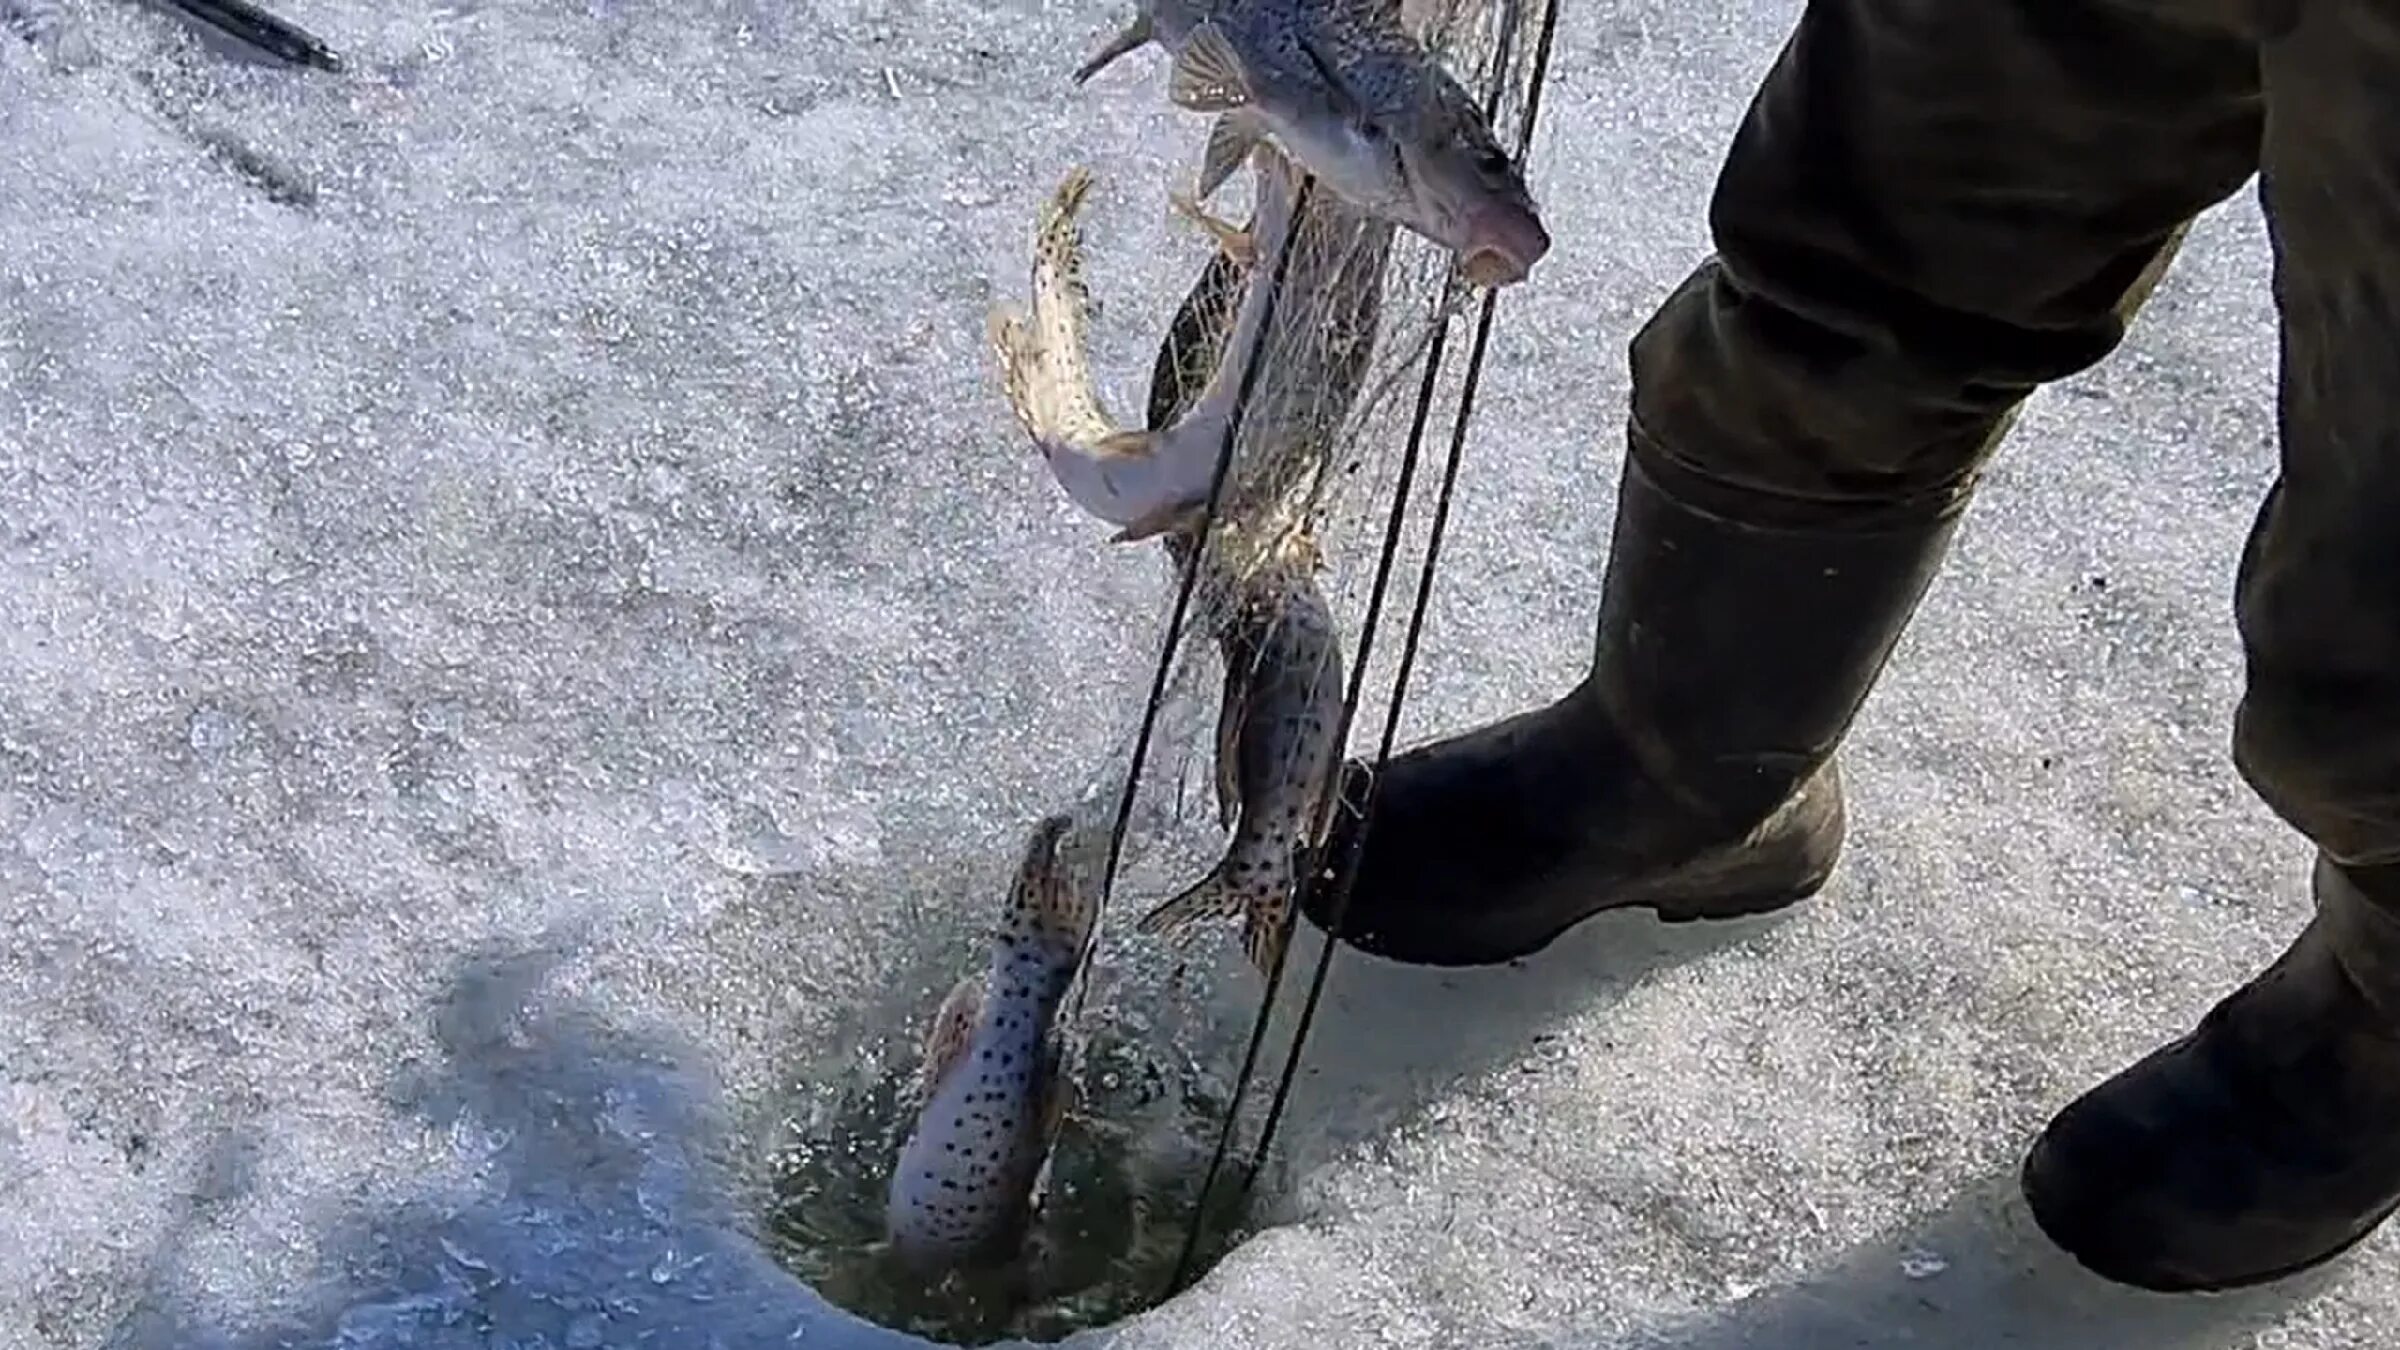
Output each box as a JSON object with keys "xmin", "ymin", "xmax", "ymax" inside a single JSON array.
[{"xmin": 1303, "ymin": 0, "xmax": 2258, "ymax": 966}]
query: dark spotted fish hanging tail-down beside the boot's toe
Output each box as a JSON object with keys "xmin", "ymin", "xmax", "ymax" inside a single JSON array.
[{"xmin": 1135, "ymin": 531, "xmax": 1342, "ymax": 973}]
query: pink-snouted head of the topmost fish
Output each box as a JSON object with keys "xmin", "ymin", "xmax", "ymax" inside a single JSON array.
[{"xmin": 1387, "ymin": 74, "xmax": 1550, "ymax": 286}]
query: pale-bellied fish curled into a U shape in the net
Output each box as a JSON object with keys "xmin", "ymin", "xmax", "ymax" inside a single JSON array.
[{"xmin": 989, "ymin": 147, "xmax": 1344, "ymax": 540}]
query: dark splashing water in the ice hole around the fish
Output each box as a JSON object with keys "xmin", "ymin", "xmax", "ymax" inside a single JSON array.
[{"xmin": 751, "ymin": 759, "xmax": 1294, "ymax": 1345}]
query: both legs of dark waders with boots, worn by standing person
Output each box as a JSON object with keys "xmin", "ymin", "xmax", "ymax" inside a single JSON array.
[{"xmin": 1152, "ymin": 0, "xmax": 2400, "ymax": 1290}]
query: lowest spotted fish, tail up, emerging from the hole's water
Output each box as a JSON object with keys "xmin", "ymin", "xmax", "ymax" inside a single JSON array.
[{"xmin": 886, "ymin": 817, "xmax": 1094, "ymax": 1268}]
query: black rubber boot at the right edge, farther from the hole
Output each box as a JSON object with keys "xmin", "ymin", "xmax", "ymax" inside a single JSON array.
[{"xmin": 2023, "ymin": 860, "xmax": 2400, "ymax": 1292}]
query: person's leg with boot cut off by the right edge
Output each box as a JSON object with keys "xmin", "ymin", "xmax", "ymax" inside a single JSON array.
[{"xmin": 2026, "ymin": 2, "xmax": 2400, "ymax": 1290}]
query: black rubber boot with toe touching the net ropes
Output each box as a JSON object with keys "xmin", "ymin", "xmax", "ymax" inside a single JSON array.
[{"xmin": 1301, "ymin": 444, "xmax": 1966, "ymax": 966}]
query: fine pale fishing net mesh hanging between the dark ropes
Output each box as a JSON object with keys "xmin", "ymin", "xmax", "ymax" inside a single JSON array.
[{"xmin": 1036, "ymin": 0, "xmax": 1538, "ymax": 951}]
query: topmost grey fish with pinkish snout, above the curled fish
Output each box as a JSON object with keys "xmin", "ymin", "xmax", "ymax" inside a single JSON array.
[{"xmin": 1075, "ymin": 0, "xmax": 1550, "ymax": 286}]
